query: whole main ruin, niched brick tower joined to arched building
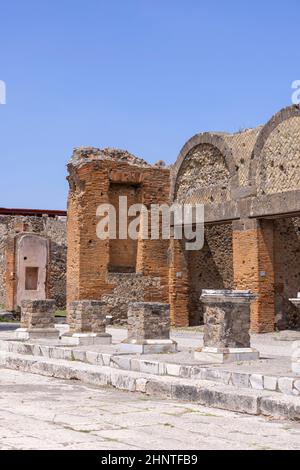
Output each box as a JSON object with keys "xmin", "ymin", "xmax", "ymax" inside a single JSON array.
[{"xmin": 67, "ymin": 106, "xmax": 300, "ymax": 333}]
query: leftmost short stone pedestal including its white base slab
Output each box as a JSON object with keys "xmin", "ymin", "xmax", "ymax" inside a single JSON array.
[{"xmin": 15, "ymin": 300, "xmax": 59, "ymax": 340}]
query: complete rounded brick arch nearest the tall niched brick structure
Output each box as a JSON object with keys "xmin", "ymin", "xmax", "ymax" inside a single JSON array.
[{"xmin": 171, "ymin": 132, "xmax": 238, "ymax": 201}]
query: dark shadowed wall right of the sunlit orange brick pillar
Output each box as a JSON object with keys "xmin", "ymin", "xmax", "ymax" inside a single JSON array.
[{"xmin": 274, "ymin": 217, "xmax": 300, "ymax": 329}]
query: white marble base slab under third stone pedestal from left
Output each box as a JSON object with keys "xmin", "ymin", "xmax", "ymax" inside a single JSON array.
[{"xmin": 119, "ymin": 339, "xmax": 177, "ymax": 354}]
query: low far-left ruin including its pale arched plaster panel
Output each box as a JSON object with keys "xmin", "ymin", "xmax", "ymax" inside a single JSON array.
[{"xmin": 0, "ymin": 209, "xmax": 67, "ymax": 312}]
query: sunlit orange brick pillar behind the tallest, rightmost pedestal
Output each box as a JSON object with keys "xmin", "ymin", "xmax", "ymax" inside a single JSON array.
[{"xmin": 233, "ymin": 219, "xmax": 275, "ymax": 333}]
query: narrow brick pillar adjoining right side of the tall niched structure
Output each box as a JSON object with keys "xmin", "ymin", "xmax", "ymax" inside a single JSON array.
[{"xmin": 169, "ymin": 238, "xmax": 189, "ymax": 327}]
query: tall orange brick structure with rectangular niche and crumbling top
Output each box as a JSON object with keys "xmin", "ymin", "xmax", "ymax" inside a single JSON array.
[{"xmin": 67, "ymin": 148, "xmax": 169, "ymax": 322}]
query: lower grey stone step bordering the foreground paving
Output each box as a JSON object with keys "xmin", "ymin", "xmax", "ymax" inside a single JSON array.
[{"xmin": 0, "ymin": 351, "xmax": 300, "ymax": 420}]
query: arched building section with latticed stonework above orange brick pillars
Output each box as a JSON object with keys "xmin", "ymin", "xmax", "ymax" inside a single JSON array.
[{"xmin": 170, "ymin": 106, "xmax": 300, "ymax": 332}]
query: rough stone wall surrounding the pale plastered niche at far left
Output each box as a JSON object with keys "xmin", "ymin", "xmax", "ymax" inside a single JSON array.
[{"xmin": 0, "ymin": 215, "xmax": 67, "ymax": 309}]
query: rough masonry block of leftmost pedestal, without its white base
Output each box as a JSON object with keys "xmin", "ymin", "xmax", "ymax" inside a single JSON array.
[{"xmin": 21, "ymin": 300, "xmax": 56, "ymax": 329}]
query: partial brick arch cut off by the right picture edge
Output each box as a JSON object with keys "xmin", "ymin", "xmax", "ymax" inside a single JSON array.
[{"xmin": 249, "ymin": 105, "xmax": 300, "ymax": 191}]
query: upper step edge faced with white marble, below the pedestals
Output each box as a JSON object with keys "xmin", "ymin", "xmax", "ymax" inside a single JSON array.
[{"xmin": 0, "ymin": 340, "xmax": 300, "ymax": 397}]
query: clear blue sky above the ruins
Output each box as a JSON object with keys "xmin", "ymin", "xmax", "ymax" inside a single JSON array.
[{"xmin": 0, "ymin": 0, "xmax": 300, "ymax": 209}]
